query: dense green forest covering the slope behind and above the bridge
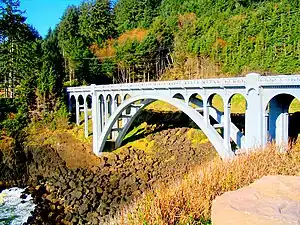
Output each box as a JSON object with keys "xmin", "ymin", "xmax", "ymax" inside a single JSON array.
[{"xmin": 0, "ymin": 0, "xmax": 300, "ymax": 132}]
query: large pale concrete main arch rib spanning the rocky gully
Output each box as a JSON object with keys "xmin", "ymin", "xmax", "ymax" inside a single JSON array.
[{"xmin": 94, "ymin": 94, "xmax": 234, "ymax": 159}]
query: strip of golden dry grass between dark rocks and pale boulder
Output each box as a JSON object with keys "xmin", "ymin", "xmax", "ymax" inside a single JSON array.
[{"xmin": 107, "ymin": 144, "xmax": 300, "ymax": 225}]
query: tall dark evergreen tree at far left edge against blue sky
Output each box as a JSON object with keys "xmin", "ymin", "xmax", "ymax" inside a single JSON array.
[{"xmin": 0, "ymin": 0, "xmax": 39, "ymax": 97}]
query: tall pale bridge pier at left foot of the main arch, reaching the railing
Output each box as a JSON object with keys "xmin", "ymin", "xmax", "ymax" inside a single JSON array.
[{"xmin": 91, "ymin": 84, "xmax": 100, "ymax": 155}]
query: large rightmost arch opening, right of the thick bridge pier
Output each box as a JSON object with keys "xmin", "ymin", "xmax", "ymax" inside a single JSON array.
[{"xmin": 264, "ymin": 94, "xmax": 300, "ymax": 146}]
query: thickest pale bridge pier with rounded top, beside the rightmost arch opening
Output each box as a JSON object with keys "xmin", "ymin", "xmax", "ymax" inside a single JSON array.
[{"xmin": 245, "ymin": 73, "xmax": 264, "ymax": 150}]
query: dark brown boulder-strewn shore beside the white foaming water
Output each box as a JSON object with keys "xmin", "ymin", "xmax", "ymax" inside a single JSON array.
[{"xmin": 0, "ymin": 124, "xmax": 215, "ymax": 224}]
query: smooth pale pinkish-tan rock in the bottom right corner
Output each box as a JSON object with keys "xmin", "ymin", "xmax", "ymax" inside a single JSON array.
[{"xmin": 212, "ymin": 176, "xmax": 300, "ymax": 225}]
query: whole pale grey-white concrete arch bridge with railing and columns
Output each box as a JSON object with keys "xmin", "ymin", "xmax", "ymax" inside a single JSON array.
[{"xmin": 67, "ymin": 73, "xmax": 300, "ymax": 159}]
